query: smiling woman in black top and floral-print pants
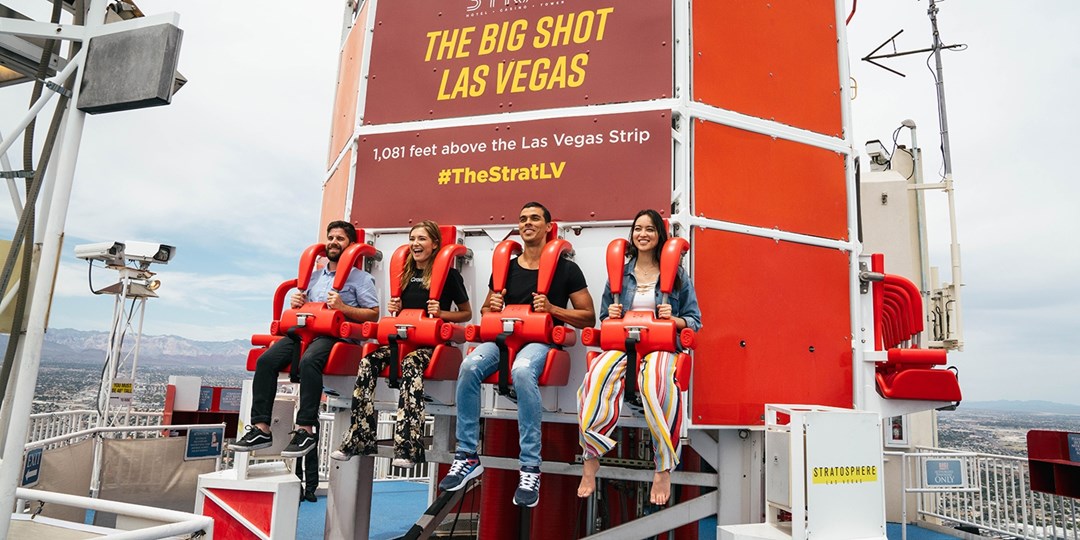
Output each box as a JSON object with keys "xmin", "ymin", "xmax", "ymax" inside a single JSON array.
[{"xmin": 330, "ymin": 220, "xmax": 472, "ymax": 469}]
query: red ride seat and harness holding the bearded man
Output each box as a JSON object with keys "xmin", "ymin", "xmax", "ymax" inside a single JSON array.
[{"xmin": 247, "ymin": 236, "xmax": 377, "ymax": 382}]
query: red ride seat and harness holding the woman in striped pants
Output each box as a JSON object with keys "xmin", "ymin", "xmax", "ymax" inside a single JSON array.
[{"xmin": 581, "ymin": 238, "xmax": 697, "ymax": 407}]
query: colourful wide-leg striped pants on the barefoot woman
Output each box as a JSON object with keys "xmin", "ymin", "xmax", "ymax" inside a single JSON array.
[{"xmin": 578, "ymin": 351, "xmax": 683, "ymax": 471}]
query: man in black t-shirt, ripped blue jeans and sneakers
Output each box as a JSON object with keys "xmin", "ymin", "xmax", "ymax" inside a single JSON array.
[{"xmin": 438, "ymin": 202, "xmax": 596, "ymax": 507}]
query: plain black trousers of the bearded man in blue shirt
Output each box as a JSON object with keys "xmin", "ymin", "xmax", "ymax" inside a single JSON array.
[{"xmin": 252, "ymin": 337, "xmax": 338, "ymax": 426}]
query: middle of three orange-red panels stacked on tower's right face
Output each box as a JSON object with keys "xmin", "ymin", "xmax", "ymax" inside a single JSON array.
[{"xmin": 693, "ymin": 120, "xmax": 848, "ymax": 240}]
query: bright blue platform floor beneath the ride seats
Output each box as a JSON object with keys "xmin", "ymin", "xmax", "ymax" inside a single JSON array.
[{"xmin": 296, "ymin": 481, "xmax": 958, "ymax": 540}]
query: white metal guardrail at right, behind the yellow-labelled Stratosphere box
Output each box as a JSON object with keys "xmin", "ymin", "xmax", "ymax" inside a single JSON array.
[{"xmin": 886, "ymin": 447, "xmax": 1080, "ymax": 540}]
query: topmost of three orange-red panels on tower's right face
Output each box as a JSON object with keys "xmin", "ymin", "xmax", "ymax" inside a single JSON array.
[{"xmin": 692, "ymin": 0, "xmax": 842, "ymax": 137}]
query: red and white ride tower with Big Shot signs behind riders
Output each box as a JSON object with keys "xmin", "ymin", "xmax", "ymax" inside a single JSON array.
[{"xmin": 321, "ymin": 0, "xmax": 963, "ymax": 538}]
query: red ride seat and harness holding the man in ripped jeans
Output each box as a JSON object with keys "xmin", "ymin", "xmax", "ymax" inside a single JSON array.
[{"xmin": 465, "ymin": 228, "xmax": 578, "ymax": 397}]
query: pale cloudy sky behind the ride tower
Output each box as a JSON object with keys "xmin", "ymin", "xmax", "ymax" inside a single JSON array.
[{"xmin": 0, "ymin": 0, "xmax": 1080, "ymax": 404}]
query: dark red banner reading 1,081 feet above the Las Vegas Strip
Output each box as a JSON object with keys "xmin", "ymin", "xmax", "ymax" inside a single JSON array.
[{"xmin": 352, "ymin": 111, "xmax": 672, "ymax": 228}]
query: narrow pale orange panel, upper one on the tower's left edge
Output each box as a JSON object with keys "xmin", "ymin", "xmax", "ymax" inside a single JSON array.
[{"xmin": 326, "ymin": 2, "xmax": 370, "ymax": 166}]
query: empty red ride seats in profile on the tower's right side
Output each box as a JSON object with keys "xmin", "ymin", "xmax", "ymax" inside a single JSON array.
[{"xmin": 870, "ymin": 254, "xmax": 961, "ymax": 402}]
